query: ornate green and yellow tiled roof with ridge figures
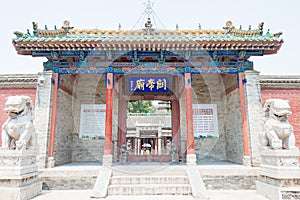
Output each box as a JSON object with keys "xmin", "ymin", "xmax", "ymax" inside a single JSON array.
[{"xmin": 13, "ymin": 21, "xmax": 283, "ymax": 54}]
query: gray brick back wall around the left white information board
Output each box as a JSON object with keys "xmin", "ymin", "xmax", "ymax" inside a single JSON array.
[{"xmin": 71, "ymin": 74, "xmax": 105, "ymax": 162}]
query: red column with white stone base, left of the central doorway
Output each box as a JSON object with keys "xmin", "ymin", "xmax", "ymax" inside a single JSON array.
[{"xmin": 103, "ymin": 73, "xmax": 113, "ymax": 166}]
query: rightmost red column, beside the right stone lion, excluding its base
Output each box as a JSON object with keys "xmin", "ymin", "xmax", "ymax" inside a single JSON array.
[{"xmin": 239, "ymin": 72, "xmax": 249, "ymax": 156}]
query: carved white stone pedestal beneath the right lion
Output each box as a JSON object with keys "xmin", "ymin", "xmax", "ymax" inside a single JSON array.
[{"xmin": 256, "ymin": 149, "xmax": 300, "ymax": 200}]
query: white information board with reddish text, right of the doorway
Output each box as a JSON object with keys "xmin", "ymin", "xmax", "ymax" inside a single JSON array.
[{"xmin": 193, "ymin": 104, "xmax": 219, "ymax": 138}]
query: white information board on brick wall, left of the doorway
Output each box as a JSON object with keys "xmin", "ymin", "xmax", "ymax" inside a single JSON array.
[{"xmin": 79, "ymin": 104, "xmax": 106, "ymax": 139}]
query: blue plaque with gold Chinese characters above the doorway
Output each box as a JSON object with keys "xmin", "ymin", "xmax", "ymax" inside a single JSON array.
[{"xmin": 128, "ymin": 76, "xmax": 169, "ymax": 92}]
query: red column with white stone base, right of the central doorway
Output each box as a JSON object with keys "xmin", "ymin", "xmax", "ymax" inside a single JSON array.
[{"xmin": 184, "ymin": 73, "xmax": 196, "ymax": 165}]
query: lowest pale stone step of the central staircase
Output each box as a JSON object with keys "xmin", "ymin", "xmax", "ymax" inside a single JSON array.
[{"xmin": 108, "ymin": 184, "xmax": 192, "ymax": 195}]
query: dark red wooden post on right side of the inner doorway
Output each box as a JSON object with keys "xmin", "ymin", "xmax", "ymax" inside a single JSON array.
[{"xmin": 171, "ymin": 99, "xmax": 181, "ymax": 160}]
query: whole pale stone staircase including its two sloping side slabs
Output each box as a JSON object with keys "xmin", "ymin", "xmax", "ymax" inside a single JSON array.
[{"xmin": 92, "ymin": 166, "xmax": 206, "ymax": 199}]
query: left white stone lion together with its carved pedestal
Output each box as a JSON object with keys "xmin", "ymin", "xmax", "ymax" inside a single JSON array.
[{"xmin": 0, "ymin": 96, "xmax": 42, "ymax": 200}]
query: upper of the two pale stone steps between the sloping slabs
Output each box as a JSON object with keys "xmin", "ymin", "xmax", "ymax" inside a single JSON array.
[{"xmin": 110, "ymin": 175, "xmax": 189, "ymax": 185}]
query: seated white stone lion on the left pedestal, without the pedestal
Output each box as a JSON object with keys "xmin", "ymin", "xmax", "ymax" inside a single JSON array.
[{"xmin": 2, "ymin": 96, "xmax": 37, "ymax": 150}]
